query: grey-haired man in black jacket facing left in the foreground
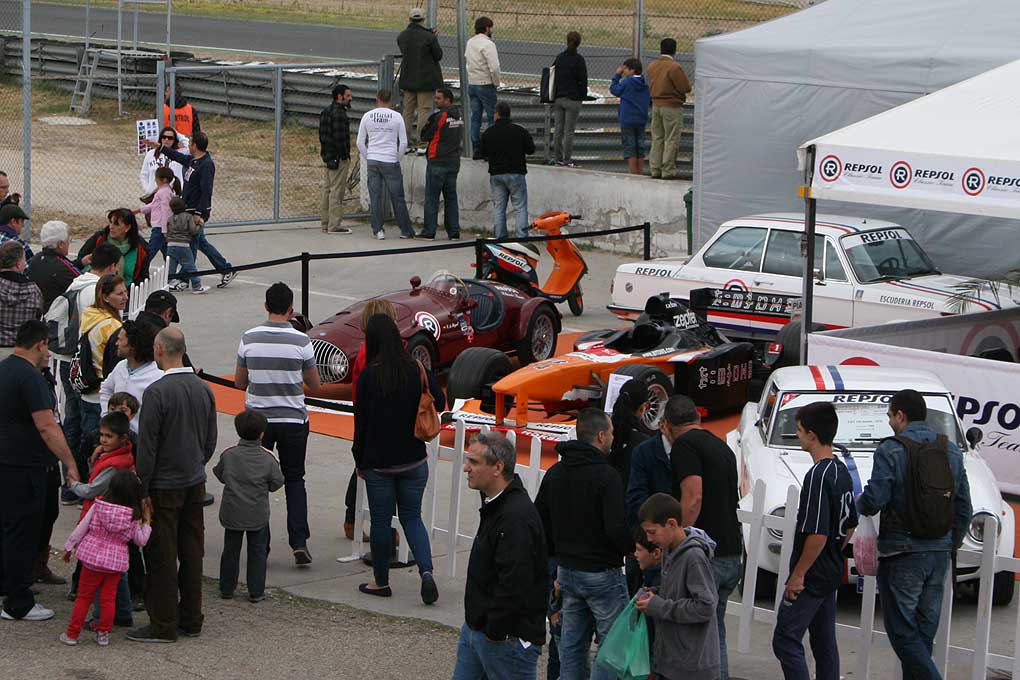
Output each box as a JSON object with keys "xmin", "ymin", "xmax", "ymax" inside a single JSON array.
[{"xmin": 453, "ymin": 432, "xmax": 549, "ymax": 680}]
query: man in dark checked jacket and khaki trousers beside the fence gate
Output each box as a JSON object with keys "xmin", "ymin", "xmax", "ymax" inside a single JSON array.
[{"xmin": 319, "ymin": 85, "xmax": 352, "ymax": 233}]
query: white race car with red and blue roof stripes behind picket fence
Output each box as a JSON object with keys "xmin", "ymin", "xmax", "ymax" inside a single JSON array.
[{"xmin": 726, "ymin": 366, "xmax": 1015, "ymax": 605}]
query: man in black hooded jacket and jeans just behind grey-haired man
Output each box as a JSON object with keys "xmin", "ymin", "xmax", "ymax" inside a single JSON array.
[{"xmin": 534, "ymin": 408, "xmax": 633, "ymax": 680}]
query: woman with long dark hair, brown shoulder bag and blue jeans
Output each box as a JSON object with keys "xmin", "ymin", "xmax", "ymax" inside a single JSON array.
[{"xmin": 353, "ymin": 314, "xmax": 439, "ymax": 605}]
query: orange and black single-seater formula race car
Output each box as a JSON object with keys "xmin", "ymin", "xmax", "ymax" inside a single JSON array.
[{"xmin": 447, "ymin": 294, "xmax": 755, "ymax": 431}]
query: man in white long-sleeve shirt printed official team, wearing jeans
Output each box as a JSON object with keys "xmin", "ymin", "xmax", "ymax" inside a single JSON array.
[{"xmin": 358, "ymin": 90, "xmax": 414, "ymax": 241}]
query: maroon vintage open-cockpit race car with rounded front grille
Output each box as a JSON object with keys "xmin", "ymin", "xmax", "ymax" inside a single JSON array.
[{"xmin": 308, "ymin": 270, "xmax": 561, "ymax": 399}]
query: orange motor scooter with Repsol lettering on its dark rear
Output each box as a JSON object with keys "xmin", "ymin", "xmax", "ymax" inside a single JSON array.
[{"xmin": 475, "ymin": 212, "xmax": 588, "ymax": 316}]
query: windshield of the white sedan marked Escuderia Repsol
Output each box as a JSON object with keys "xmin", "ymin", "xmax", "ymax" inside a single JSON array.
[{"xmin": 839, "ymin": 228, "xmax": 938, "ymax": 283}]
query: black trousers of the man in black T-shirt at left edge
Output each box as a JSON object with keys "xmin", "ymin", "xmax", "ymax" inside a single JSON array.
[{"xmin": 0, "ymin": 465, "xmax": 47, "ymax": 619}]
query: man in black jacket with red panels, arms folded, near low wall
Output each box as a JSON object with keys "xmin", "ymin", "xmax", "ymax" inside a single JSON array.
[{"xmin": 417, "ymin": 88, "xmax": 464, "ymax": 241}]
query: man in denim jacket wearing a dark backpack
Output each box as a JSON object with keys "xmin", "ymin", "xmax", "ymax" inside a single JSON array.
[{"xmin": 857, "ymin": 389, "xmax": 971, "ymax": 680}]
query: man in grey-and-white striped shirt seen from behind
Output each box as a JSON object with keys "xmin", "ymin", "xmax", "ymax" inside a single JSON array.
[{"xmin": 234, "ymin": 283, "xmax": 319, "ymax": 567}]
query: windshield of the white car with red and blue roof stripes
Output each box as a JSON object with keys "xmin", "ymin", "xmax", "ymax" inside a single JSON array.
[{"xmin": 769, "ymin": 391, "xmax": 967, "ymax": 453}]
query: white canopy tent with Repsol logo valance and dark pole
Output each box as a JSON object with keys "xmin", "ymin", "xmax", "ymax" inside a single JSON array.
[{"xmin": 798, "ymin": 60, "xmax": 1020, "ymax": 359}]
